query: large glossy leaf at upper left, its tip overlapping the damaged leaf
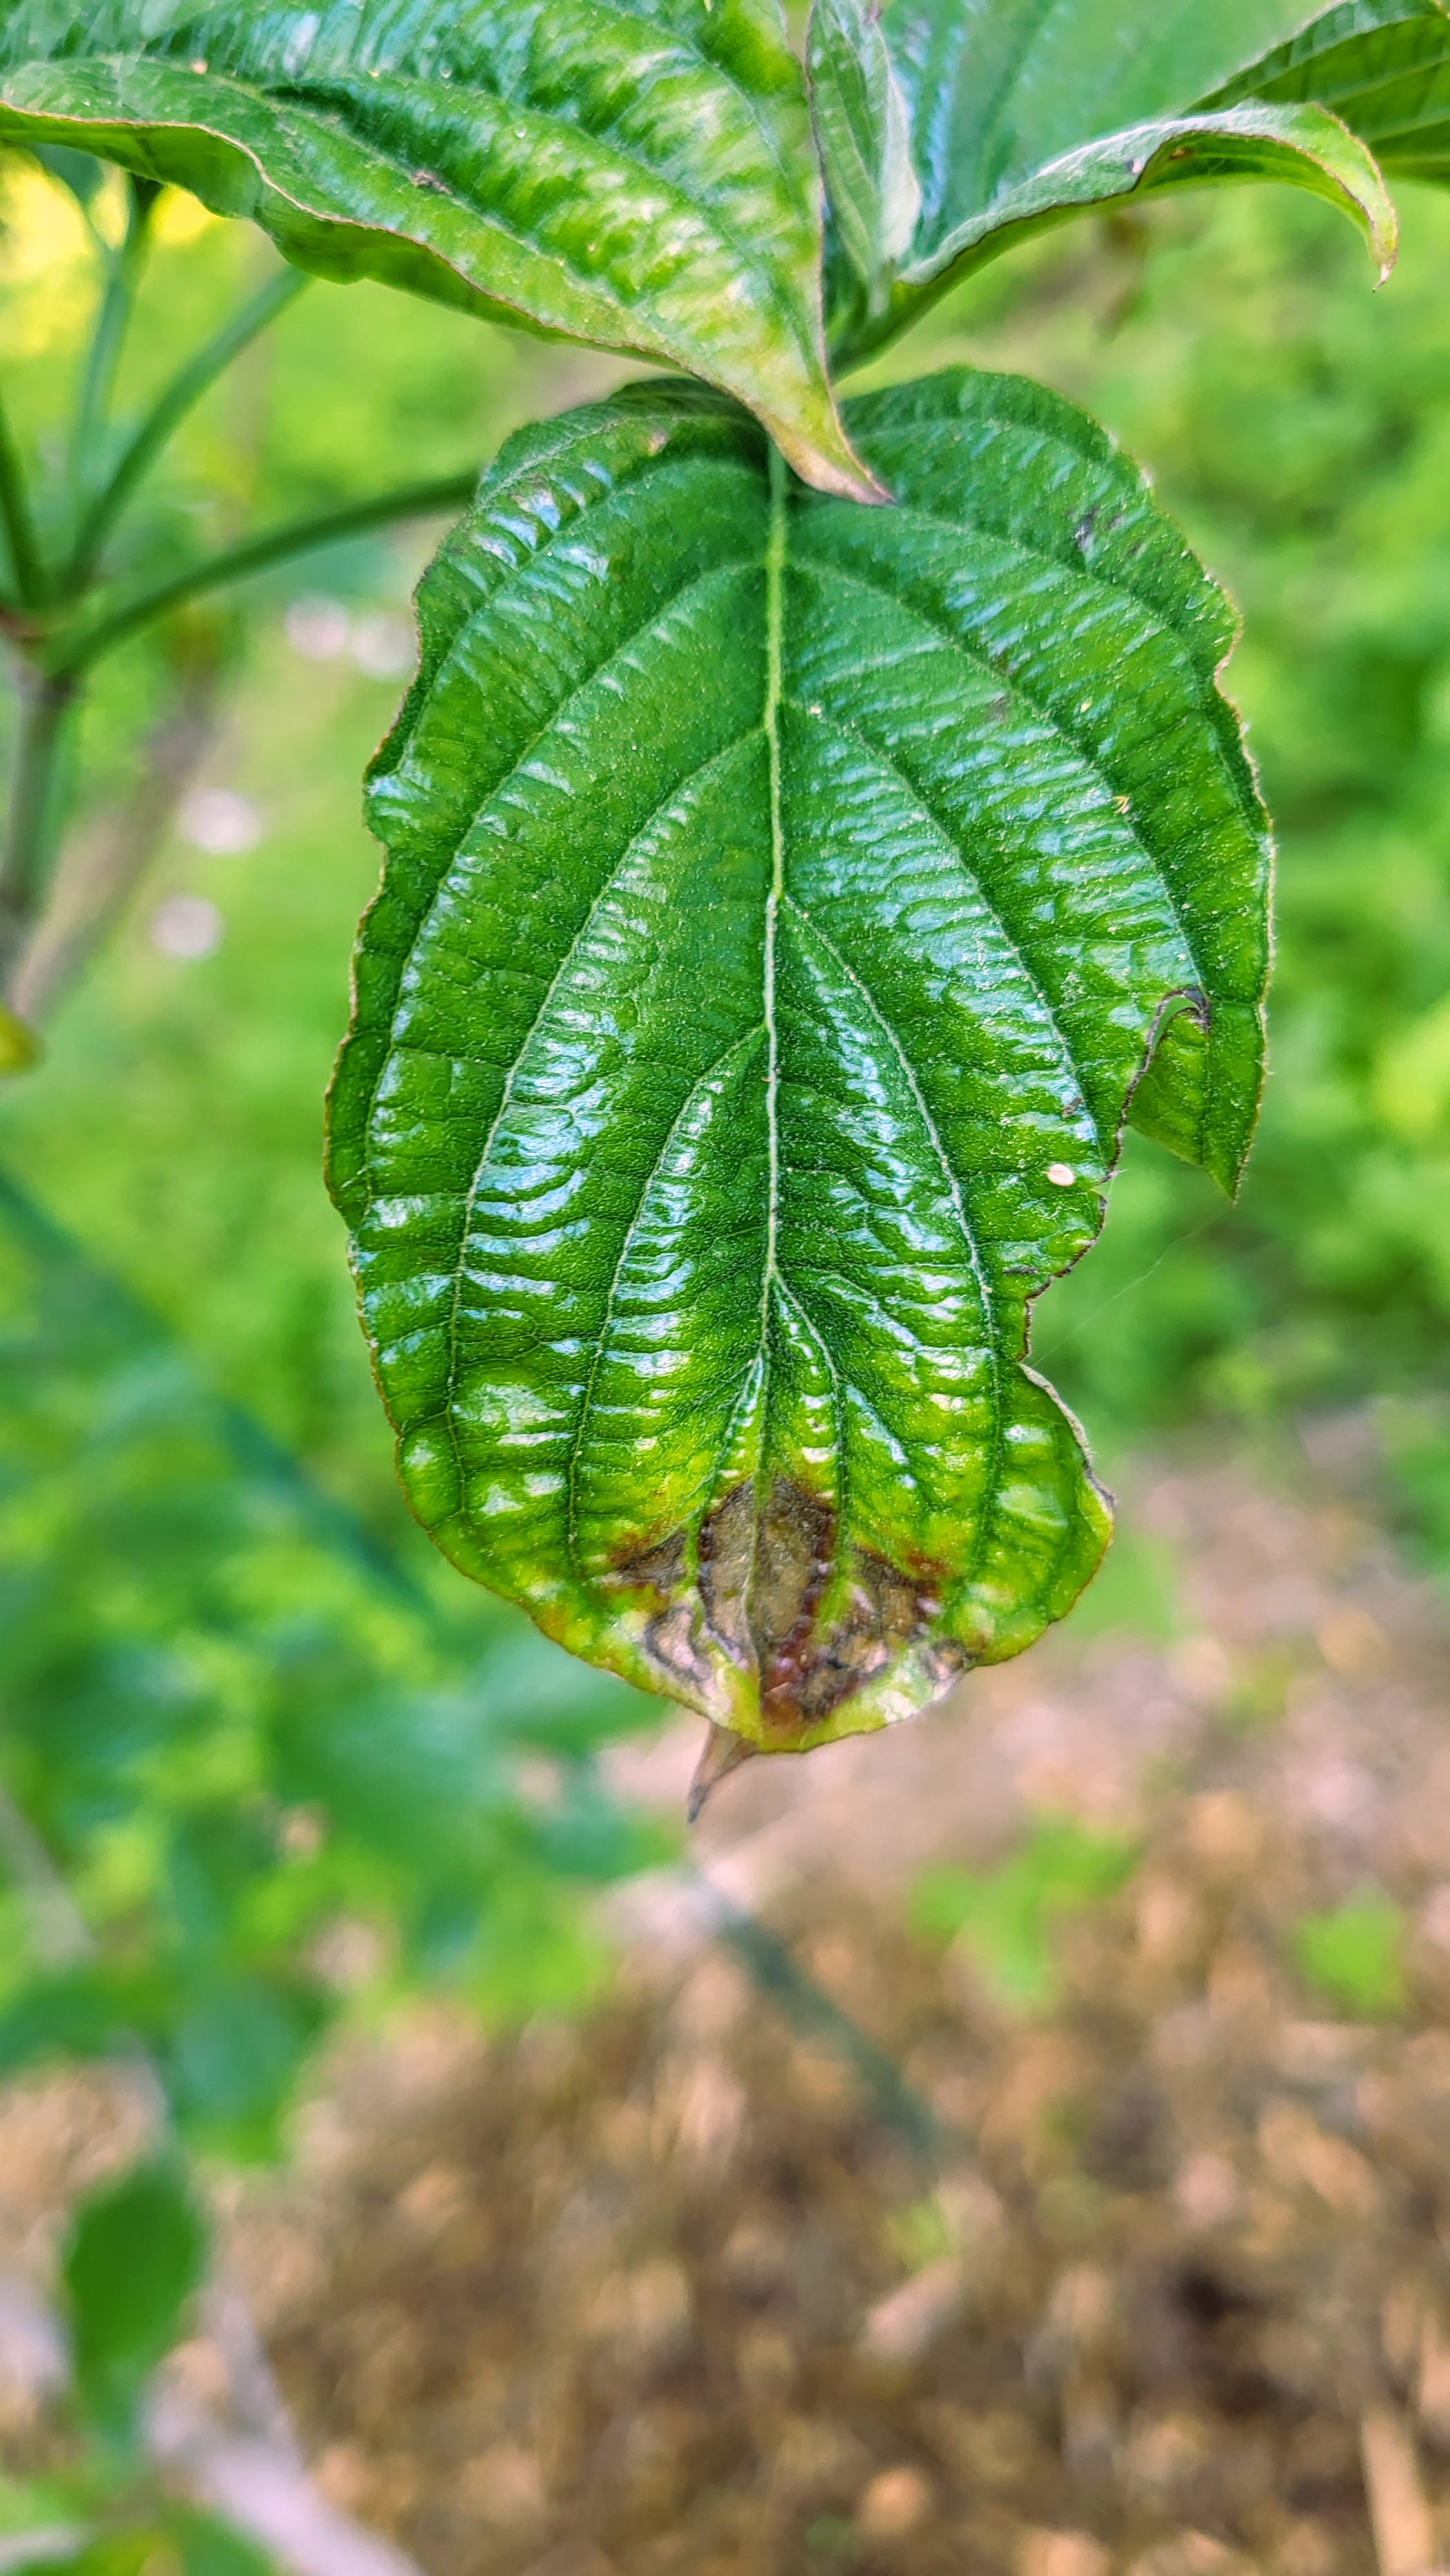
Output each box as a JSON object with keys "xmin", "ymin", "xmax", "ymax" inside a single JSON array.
[{"xmin": 0, "ymin": 0, "xmax": 868, "ymax": 497}]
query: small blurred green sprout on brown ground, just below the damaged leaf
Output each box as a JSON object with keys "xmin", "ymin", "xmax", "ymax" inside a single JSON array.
[{"xmin": 912, "ymin": 1816, "xmax": 1138, "ymax": 2012}]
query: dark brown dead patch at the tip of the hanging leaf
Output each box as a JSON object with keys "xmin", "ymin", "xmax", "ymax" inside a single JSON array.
[{"xmin": 613, "ymin": 1476, "xmax": 966, "ymax": 1747}]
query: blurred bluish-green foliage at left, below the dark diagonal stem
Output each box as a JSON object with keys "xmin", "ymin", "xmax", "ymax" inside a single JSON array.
[{"xmin": 0, "ymin": 1180, "xmax": 675, "ymax": 2154}]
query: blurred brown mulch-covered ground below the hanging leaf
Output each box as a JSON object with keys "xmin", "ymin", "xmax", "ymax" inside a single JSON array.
[{"xmin": 0, "ymin": 1443, "xmax": 1450, "ymax": 2576}]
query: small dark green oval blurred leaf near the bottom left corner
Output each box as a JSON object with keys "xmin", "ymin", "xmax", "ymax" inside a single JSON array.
[{"xmin": 62, "ymin": 2161, "xmax": 206, "ymax": 2434}]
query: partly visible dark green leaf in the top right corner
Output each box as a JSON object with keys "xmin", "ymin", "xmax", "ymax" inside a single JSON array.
[{"xmin": 1208, "ymin": 0, "xmax": 1450, "ymax": 180}]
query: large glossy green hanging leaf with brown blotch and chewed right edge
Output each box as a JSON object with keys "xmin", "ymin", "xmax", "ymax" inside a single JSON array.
[{"xmin": 332, "ymin": 371, "xmax": 1267, "ymax": 1749}]
